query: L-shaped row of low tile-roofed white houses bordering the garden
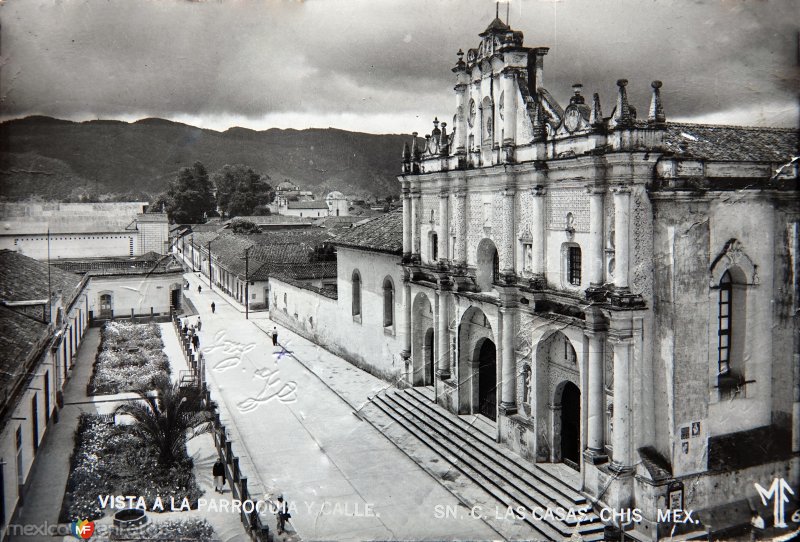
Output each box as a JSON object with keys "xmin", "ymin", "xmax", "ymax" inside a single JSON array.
[{"xmin": 0, "ymin": 251, "xmax": 183, "ymax": 540}]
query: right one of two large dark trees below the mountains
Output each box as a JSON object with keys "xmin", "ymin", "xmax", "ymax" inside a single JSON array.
[{"xmin": 213, "ymin": 164, "xmax": 275, "ymax": 218}]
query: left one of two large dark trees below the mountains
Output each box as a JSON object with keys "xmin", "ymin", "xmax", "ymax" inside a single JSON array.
[{"xmin": 153, "ymin": 162, "xmax": 215, "ymax": 224}]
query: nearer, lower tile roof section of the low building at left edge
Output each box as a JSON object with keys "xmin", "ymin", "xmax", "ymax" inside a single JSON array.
[{"xmin": 0, "ymin": 305, "xmax": 50, "ymax": 407}]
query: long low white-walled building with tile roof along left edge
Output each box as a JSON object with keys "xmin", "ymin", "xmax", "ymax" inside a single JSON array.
[{"xmin": 0, "ymin": 250, "xmax": 89, "ymax": 539}]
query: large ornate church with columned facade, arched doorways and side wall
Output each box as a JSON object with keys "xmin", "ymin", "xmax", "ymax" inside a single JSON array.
[{"xmin": 399, "ymin": 15, "xmax": 800, "ymax": 537}]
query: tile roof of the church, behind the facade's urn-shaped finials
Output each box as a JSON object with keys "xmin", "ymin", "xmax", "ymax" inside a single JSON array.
[{"xmin": 664, "ymin": 123, "xmax": 798, "ymax": 162}]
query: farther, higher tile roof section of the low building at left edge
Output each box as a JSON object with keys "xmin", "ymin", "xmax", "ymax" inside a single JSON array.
[{"xmin": 0, "ymin": 250, "xmax": 82, "ymax": 306}]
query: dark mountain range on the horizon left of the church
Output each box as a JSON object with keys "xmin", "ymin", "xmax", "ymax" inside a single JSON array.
[{"xmin": 0, "ymin": 116, "xmax": 411, "ymax": 200}]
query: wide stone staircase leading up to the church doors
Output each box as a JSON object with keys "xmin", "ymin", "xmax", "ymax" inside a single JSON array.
[{"xmin": 361, "ymin": 388, "xmax": 603, "ymax": 541}]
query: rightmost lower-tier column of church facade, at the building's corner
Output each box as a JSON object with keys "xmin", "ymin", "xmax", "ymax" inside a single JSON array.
[{"xmin": 611, "ymin": 337, "xmax": 633, "ymax": 472}]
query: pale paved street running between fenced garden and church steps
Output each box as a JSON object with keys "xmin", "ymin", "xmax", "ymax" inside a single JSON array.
[{"xmin": 186, "ymin": 274, "xmax": 498, "ymax": 540}]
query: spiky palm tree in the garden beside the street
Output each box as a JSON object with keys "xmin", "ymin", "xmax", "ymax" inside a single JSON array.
[{"xmin": 114, "ymin": 375, "xmax": 212, "ymax": 466}]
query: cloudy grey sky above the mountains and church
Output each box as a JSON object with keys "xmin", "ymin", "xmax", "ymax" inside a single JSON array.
[{"xmin": 0, "ymin": 0, "xmax": 800, "ymax": 133}]
